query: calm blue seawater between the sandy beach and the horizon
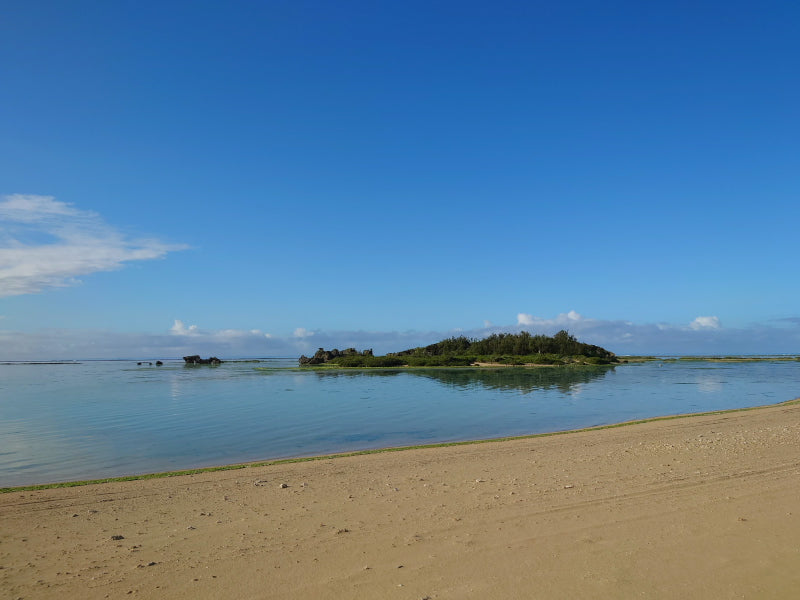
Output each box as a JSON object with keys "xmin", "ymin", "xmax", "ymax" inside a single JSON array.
[{"xmin": 0, "ymin": 359, "xmax": 800, "ymax": 487}]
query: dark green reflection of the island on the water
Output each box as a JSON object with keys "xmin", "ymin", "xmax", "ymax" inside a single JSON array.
[{"xmin": 314, "ymin": 366, "xmax": 614, "ymax": 394}]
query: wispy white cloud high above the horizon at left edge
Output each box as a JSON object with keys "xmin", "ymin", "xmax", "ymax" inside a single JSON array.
[{"xmin": 0, "ymin": 194, "xmax": 187, "ymax": 297}]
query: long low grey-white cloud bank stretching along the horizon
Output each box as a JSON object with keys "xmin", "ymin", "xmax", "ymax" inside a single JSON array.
[{"xmin": 0, "ymin": 311, "xmax": 800, "ymax": 360}]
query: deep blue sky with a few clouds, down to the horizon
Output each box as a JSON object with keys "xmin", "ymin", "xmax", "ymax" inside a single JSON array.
[{"xmin": 0, "ymin": 0, "xmax": 800, "ymax": 360}]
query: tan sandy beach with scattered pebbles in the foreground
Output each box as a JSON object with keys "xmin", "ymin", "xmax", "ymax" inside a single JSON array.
[{"xmin": 0, "ymin": 403, "xmax": 800, "ymax": 600}]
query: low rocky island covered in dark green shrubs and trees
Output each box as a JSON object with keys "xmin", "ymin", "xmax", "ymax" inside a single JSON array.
[{"xmin": 300, "ymin": 330, "xmax": 619, "ymax": 367}]
